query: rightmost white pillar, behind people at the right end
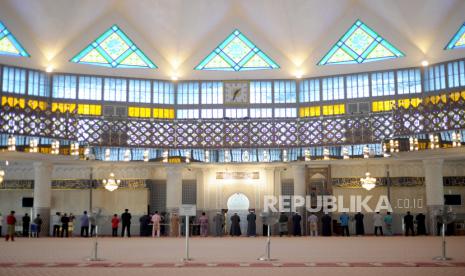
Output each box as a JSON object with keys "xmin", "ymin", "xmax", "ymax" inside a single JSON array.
[{"xmin": 423, "ymin": 159, "xmax": 444, "ymax": 235}]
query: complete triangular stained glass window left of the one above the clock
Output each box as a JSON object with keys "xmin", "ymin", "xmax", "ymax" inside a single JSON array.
[{"xmin": 71, "ymin": 25, "xmax": 157, "ymax": 68}]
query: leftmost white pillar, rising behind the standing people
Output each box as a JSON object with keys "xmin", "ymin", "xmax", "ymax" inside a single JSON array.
[{"xmin": 32, "ymin": 162, "xmax": 53, "ymax": 235}]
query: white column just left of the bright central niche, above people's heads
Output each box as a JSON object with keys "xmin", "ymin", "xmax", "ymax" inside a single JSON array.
[{"xmin": 166, "ymin": 165, "xmax": 182, "ymax": 211}]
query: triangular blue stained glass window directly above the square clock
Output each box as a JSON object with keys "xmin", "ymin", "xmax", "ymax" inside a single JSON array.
[{"xmin": 195, "ymin": 30, "xmax": 279, "ymax": 71}]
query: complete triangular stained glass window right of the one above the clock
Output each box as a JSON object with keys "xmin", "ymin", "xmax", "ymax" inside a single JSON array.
[{"xmin": 318, "ymin": 20, "xmax": 404, "ymax": 65}]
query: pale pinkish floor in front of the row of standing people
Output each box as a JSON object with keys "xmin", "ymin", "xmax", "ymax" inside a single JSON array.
[{"xmin": 0, "ymin": 236, "xmax": 465, "ymax": 276}]
